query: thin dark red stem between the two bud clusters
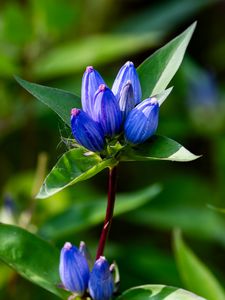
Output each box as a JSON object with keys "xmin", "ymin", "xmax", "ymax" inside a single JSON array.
[{"xmin": 96, "ymin": 166, "xmax": 117, "ymax": 260}]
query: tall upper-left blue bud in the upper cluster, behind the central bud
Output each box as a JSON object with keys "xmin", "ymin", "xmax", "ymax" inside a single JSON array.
[{"xmin": 81, "ymin": 66, "xmax": 104, "ymax": 116}]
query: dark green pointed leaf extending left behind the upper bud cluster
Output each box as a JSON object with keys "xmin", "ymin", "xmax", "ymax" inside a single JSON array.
[{"xmin": 15, "ymin": 76, "xmax": 81, "ymax": 126}]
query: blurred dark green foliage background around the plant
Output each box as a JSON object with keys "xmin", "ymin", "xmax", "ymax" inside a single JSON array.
[{"xmin": 0, "ymin": 0, "xmax": 225, "ymax": 300}]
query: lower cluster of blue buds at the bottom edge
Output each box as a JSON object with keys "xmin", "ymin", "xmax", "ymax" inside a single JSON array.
[{"xmin": 59, "ymin": 242, "xmax": 114, "ymax": 300}]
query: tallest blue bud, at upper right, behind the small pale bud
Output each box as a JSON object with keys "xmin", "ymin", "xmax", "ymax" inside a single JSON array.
[{"xmin": 112, "ymin": 61, "xmax": 141, "ymax": 105}]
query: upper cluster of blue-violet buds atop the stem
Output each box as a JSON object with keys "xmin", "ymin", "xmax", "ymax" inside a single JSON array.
[{"xmin": 71, "ymin": 61, "xmax": 159, "ymax": 152}]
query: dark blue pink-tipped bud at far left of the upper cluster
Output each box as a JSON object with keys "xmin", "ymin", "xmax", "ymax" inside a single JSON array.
[{"xmin": 71, "ymin": 108, "xmax": 105, "ymax": 152}]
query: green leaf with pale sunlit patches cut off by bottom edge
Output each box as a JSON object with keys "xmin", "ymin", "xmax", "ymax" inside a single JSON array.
[{"xmin": 116, "ymin": 284, "xmax": 206, "ymax": 300}]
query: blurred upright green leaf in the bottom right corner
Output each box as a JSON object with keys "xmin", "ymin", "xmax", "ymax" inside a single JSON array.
[{"xmin": 174, "ymin": 230, "xmax": 225, "ymax": 300}]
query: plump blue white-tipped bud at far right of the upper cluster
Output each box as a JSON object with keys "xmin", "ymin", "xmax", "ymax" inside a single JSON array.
[{"xmin": 124, "ymin": 98, "xmax": 159, "ymax": 144}]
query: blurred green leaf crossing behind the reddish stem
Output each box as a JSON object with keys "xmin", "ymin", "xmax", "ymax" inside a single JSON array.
[{"xmin": 40, "ymin": 184, "xmax": 161, "ymax": 239}]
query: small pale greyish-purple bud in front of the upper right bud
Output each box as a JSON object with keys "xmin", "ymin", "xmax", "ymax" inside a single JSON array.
[{"xmin": 119, "ymin": 80, "xmax": 135, "ymax": 120}]
